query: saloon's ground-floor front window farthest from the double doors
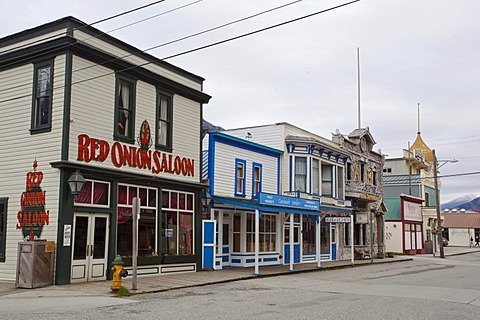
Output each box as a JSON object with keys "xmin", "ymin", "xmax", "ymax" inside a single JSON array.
[{"xmin": 161, "ymin": 190, "xmax": 195, "ymax": 256}]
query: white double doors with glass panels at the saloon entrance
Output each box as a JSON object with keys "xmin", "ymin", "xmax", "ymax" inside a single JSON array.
[{"xmin": 71, "ymin": 213, "xmax": 110, "ymax": 282}]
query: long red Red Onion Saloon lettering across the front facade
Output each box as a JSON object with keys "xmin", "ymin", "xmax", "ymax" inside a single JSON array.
[{"xmin": 77, "ymin": 133, "xmax": 195, "ymax": 177}]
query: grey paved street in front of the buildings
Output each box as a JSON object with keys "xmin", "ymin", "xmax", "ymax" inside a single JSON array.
[{"xmin": 0, "ymin": 252, "xmax": 480, "ymax": 320}]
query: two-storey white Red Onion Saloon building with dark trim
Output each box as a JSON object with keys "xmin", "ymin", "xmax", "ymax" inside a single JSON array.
[{"xmin": 0, "ymin": 17, "xmax": 210, "ymax": 284}]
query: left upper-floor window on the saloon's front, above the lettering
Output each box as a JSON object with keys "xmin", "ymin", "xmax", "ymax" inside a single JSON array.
[{"xmin": 115, "ymin": 76, "xmax": 135, "ymax": 143}]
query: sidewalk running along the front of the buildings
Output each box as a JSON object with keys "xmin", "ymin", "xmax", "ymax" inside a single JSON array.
[{"xmin": 0, "ymin": 247, "xmax": 480, "ymax": 298}]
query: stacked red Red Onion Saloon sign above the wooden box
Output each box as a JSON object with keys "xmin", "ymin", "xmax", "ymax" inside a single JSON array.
[{"xmin": 16, "ymin": 160, "xmax": 50, "ymax": 240}]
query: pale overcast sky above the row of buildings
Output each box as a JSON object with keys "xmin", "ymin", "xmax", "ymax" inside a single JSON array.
[{"xmin": 0, "ymin": 0, "xmax": 480, "ymax": 203}]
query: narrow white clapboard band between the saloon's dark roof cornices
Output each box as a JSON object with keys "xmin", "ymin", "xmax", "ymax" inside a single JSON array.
[{"xmin": 74, "ymin": 30, "xmax": 202, "ymax": 91}]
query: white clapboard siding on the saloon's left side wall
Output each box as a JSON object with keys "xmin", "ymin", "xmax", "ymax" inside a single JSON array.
[{"xmin": 0, "ymin": 55, "xmax": 65, "ymax": 280}]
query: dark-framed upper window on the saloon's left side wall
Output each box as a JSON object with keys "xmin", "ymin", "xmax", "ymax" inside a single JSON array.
[{"xmin": 31, "ymin": 62, "xmax": 53, "ymax": 132}]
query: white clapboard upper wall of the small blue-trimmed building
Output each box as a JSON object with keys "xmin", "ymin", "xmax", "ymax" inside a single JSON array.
[{"xmin": 213, "ymin": 142, "xmax": 278, "ymax": 198}]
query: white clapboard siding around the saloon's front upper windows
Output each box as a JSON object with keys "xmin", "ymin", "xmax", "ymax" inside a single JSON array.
[{"xmin": 69, "ymin": 56, "xmax": 201, "ymax": 182}]
